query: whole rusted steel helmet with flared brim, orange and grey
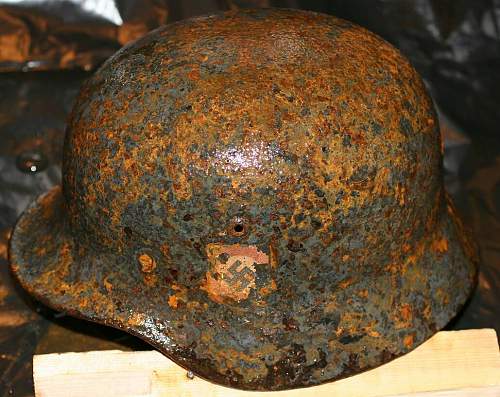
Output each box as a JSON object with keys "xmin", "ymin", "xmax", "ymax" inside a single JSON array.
[{"xmin": 10, "ymin": 9, "xmax": 476, "ymax": 390}]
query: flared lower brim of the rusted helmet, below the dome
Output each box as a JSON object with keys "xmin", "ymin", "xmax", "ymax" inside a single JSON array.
[{"xmin": 9, "ymin": 187, "xmax": 477, "ymax": 390}]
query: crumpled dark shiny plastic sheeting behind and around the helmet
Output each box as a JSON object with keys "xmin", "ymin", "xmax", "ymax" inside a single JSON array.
[{"xmin": 0, "ymin": 0, "xmax": 500, "ymax": 396}]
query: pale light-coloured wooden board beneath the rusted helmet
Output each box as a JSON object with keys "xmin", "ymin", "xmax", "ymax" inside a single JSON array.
[{"xmin": 33, "ymin": 329, "xmax": 500, "ymax": 397}]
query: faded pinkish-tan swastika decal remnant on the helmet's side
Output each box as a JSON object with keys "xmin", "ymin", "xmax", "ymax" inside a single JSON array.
[{"xmin": 201, "ymin": 244, "xmax": 269, "ymax": 303}]
